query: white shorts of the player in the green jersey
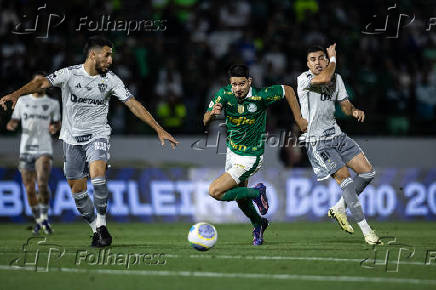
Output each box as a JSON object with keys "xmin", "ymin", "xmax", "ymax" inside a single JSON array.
[{"xmin": 225, "ymin": 148, "xmax": 263, "ymax": 184}]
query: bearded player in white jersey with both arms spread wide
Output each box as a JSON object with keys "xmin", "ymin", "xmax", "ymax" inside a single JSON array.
[{"xmin": 0, "ymin": 37, "xmax": 178, "ymax": 247}]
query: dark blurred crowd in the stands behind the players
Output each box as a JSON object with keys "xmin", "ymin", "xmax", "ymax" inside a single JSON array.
[{"xmin": 0, "ymin": 0, "xmax": 436, "ymax": 143}]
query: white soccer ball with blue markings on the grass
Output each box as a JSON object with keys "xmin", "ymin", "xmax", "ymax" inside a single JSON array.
[{"xmin": 188, "ymin": 223, "xmax": 218, "ymax": 251}]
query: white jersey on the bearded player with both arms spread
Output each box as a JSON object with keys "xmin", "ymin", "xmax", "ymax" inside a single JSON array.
[{"xmin": 47, "ymin": 64, "xmax": 132, "ymax": 145}]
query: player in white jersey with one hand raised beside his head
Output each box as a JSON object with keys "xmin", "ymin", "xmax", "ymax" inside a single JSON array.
[{"xmin": 297, "ymin": 44, "xmax": 381, "ymax": 245}]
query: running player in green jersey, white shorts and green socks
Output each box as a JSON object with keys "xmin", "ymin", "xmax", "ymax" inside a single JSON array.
[{"xmin": 203, "ymin": 64, "xmax": 307, "ymax": 246}]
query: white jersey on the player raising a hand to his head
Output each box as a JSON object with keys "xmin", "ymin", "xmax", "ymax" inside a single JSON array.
[{"xmin": 297, "ymin": 70, "xmax": 348, "ymax": 141}]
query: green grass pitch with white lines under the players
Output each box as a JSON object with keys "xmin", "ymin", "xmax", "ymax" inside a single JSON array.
[{"xmin": 0, "ymin": 222, "xmax": 436, "ymax": 290}]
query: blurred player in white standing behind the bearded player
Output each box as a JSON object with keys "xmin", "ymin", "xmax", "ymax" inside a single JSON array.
[{"xmin": 6, "ymin": 75, "xmax": 60, "ymax": 235}]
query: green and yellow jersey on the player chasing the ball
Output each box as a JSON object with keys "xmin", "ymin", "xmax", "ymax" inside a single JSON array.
[{"xmin": 207, "ymin": 85, "xmax": 284, "ymax": 156}]
